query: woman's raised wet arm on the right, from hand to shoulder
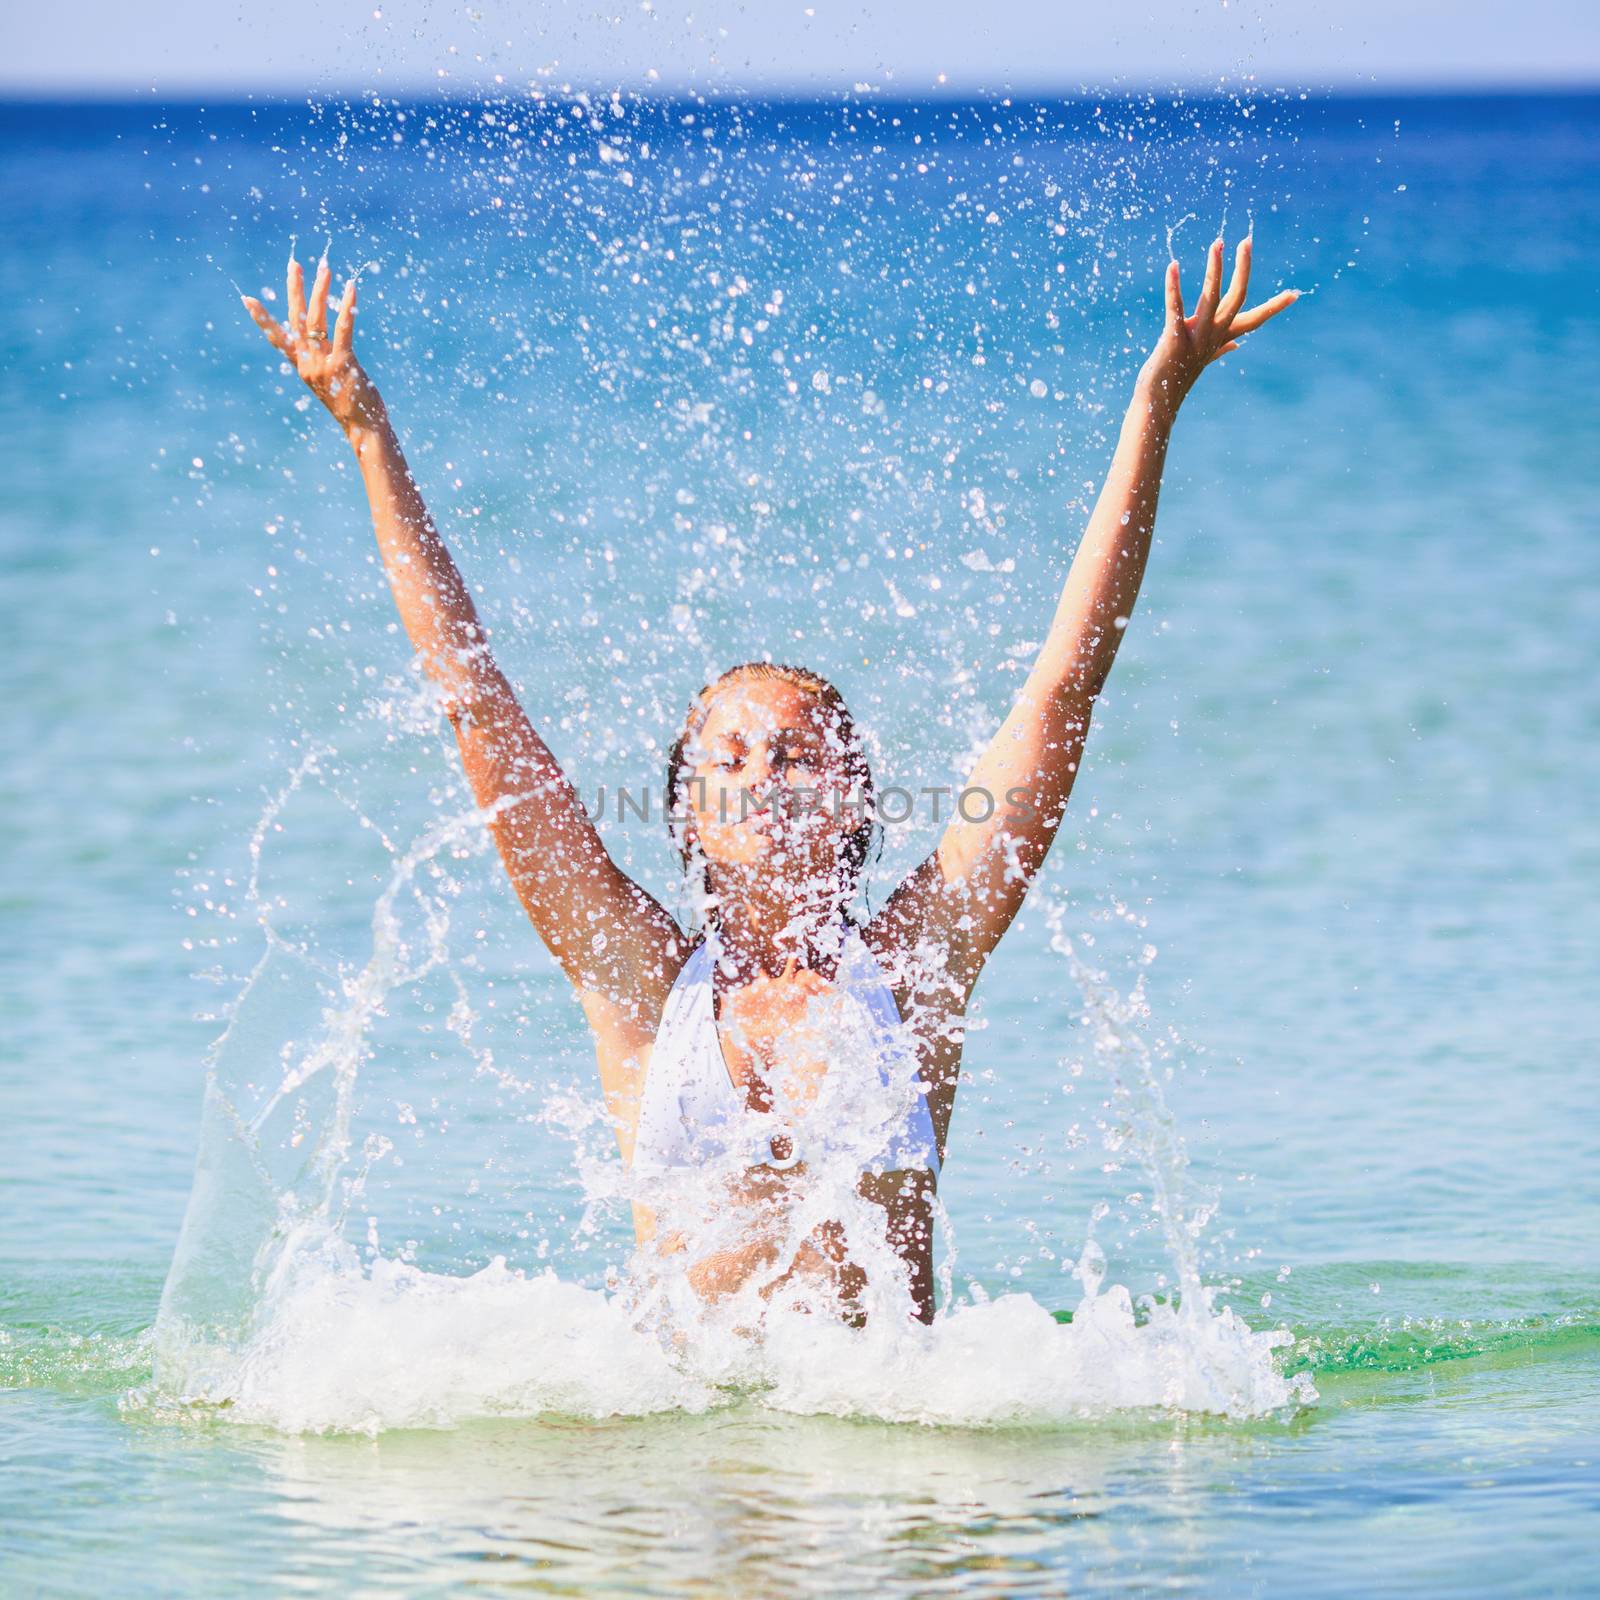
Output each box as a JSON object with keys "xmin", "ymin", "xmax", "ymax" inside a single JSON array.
[{"xmin": 883, "ymin": 238, "xmax": 1296, "ymax": 982}]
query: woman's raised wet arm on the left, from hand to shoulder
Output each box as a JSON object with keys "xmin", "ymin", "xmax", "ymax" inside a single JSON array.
[{"xmin": 245, "ymin": 256, "xmax": 686, "ymax": 1026}]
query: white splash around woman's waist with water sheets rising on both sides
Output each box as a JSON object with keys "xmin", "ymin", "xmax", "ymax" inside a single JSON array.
[{"xmin": 147, "ymin": 750, "xmax": 1315, "ymax": 1432}]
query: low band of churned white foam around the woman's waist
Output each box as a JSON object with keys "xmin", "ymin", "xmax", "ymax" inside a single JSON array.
[{"xmin": 144, "ymin": 1216, "xmax": 1315, "ymax": 1434}]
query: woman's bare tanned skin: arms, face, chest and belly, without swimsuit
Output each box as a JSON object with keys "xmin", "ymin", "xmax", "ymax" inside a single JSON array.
[{"xmin": 245, "ymin": 238, "xmax": 1298, "ymax": 1320}]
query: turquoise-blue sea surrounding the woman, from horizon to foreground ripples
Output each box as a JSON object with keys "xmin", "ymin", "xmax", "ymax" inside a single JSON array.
[{"xmin": 0, "ymin": 96, "xmax": 1600, "ymax": 1595}]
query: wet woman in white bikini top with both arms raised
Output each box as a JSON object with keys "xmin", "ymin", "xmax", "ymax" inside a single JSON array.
[{"xmin": 245, "ymin": 238, "xmax": 1296, "ymax": 1320}]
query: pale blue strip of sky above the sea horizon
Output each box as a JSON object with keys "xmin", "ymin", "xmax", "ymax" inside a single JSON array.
[{"xmin": 12, "ymin": 0, "xmax": 1600, "ymax": 93}]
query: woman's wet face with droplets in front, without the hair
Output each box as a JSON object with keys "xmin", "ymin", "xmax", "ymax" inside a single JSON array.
[{"xmin": 683, "ymin": 678, "xmax": 862, "ymax": 894}]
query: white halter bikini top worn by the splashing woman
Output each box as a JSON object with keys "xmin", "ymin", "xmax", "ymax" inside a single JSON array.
[{"xmin": 634, "ymin": 925, "xmax": 939, "ymax": 1174}]
